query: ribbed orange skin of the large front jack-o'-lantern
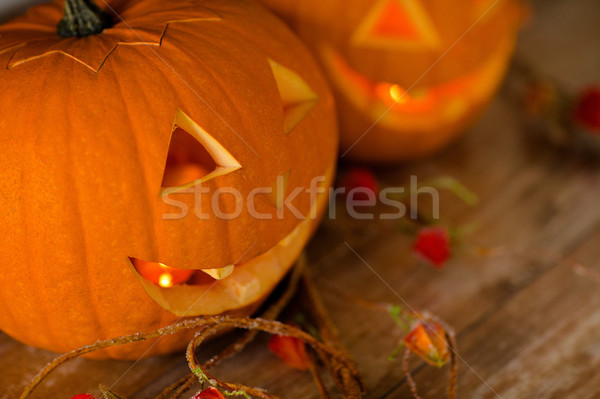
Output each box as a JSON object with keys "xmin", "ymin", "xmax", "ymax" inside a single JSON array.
[{"xmin": 0, "ymin": 0, "xmax": 338, "ymax": 359}]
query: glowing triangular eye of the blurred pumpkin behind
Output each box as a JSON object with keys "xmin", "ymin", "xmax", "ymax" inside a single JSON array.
[{"xmin": 351, "ymin": 0, "xmax": 440, "ymax": 49}]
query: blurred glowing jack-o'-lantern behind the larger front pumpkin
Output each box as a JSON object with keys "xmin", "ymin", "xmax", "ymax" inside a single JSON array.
[{"xmin": 255, "ymin": 0, "xmax": 522, "ymax": 162}]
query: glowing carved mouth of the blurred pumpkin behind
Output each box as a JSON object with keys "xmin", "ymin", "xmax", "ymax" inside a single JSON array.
[{"xmin": 320, "ymin": 40, "xmax": 511, "ymax": 130}]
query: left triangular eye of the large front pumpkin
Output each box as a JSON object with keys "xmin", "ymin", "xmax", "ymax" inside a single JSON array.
[{"xmin": 161, "ymin": 110, "xmax": 241, "ymax": 195}]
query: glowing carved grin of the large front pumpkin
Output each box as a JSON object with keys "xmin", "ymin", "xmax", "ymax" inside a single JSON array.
[{"xmin": 129, "ymin": 167, "xmax": 334, "ymax": 317}]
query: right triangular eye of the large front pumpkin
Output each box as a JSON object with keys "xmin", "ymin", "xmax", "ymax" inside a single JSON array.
[{"xmin": 269, "ymin": 59, "xmax": 319, "ymax": 134}]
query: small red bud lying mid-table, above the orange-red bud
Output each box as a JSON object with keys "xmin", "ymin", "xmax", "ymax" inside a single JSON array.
[{"xmin": 413, "ymin": 227, "xmax": 452, "ymax": 269}]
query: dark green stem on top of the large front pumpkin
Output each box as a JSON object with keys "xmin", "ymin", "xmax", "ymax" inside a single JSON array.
[{"xmin": 58, "ymin": 0, "xmax": 113, "ymax": 37}]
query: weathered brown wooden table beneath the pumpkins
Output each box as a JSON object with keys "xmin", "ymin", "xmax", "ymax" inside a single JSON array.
[{"xmin": 0, "ymin": 0, "xmax": 600, "ymax": 399}]
